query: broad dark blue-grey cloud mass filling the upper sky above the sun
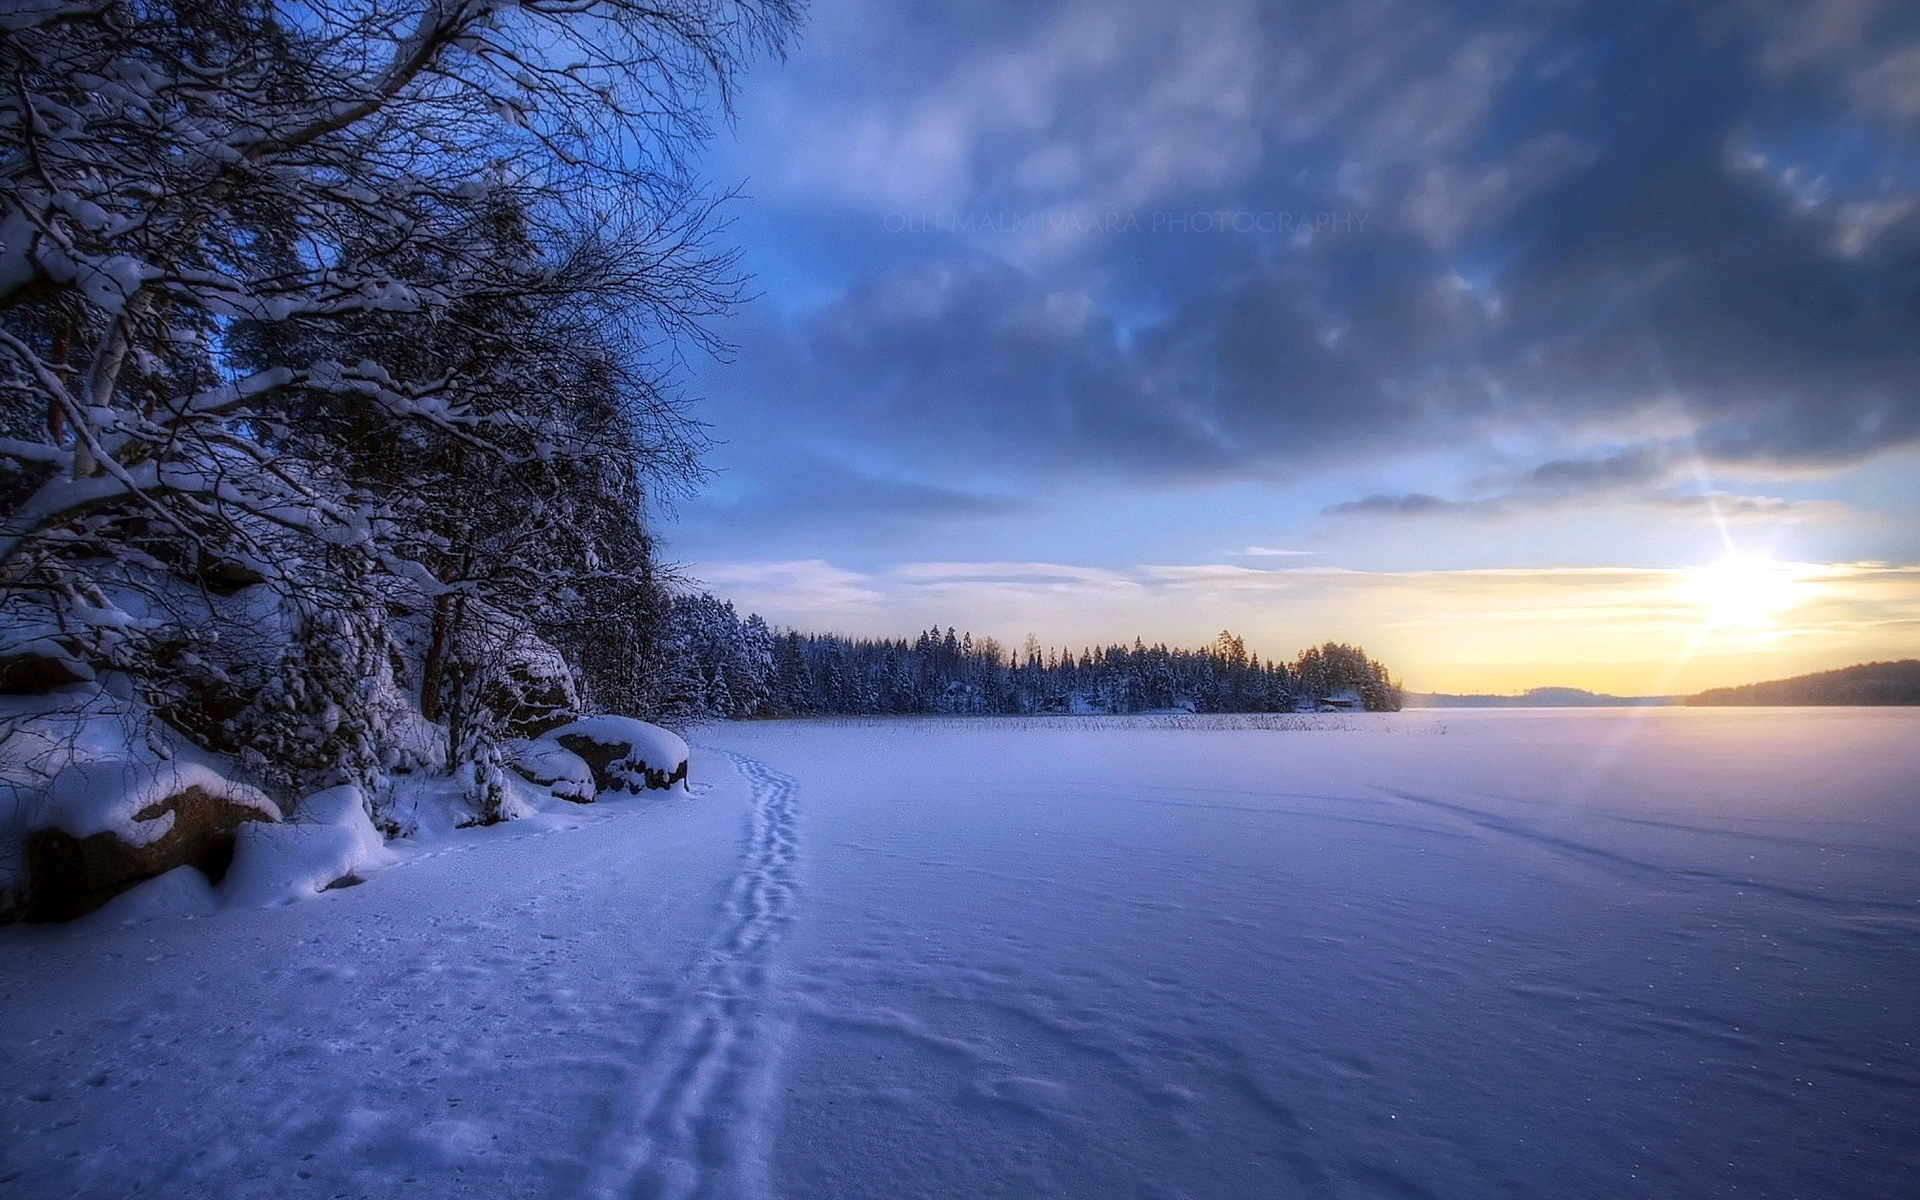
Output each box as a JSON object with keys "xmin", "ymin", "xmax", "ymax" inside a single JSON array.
[{"xmin": 698, "ymin": 0, "xmax": 1920, "ymax": 537}]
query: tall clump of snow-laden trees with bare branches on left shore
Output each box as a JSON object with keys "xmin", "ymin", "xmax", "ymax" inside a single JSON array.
[{"xmin": 0, "ymin": 0, "xmax": 795, "ymax": 814}]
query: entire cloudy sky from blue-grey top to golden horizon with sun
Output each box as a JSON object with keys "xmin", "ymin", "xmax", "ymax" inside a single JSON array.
[{"xmin": 662, "ymin": 0, "xmax": 1920, "ymax": 693}]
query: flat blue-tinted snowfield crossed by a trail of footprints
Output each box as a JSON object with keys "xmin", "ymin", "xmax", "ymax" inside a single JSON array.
[{"xmin": 0, "ymin": 710, "xmax": 1920, "ymax": 1200}]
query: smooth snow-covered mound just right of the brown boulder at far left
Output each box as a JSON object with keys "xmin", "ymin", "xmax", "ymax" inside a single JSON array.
[{"xmin": 221, "ymin": 783, "xmax": 388, "ymax": 908}]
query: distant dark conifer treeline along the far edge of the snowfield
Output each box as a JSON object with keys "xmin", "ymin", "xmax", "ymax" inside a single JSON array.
[{"xmin": 664, "ymin": 595, "xmax": 1402, "ymax": 720}]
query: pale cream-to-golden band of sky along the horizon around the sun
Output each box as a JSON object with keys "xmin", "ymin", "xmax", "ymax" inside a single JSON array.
[{"xmin": 707, "ymin": 559, "xmax": 1920, "ymax": 695}]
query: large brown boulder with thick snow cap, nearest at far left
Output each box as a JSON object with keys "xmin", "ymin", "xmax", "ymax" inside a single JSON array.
[{"xmin": 21, "ymin": 760, "xmax": 280, "ymax": 922}]
